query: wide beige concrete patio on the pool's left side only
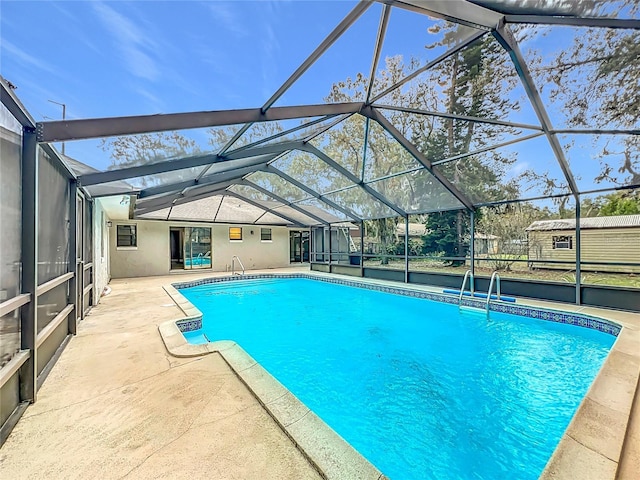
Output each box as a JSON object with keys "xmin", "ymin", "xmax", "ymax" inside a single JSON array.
[{"xmin": 0, "ymin": 269, "xmax": 321, "ymax": 479}]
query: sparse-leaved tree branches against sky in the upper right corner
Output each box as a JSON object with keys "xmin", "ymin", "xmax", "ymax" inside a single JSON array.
[{"xmin": 518, "ymin": 0, "xmax": 640, "ymax": 186}]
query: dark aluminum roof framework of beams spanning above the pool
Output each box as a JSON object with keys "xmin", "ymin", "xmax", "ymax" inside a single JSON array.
[{"xmin": 22, "ymin": 0, "xmax": 640, "ymax": 294}]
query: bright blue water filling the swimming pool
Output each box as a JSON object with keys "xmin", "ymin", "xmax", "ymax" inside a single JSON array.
[{"xmin": 180, "ymin": 279, "xmax": 615, "ymax": 480}]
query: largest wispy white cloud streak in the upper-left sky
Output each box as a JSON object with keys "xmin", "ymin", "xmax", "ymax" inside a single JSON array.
[{"xmin": 93, "ymin": 2, "xmax": 160, "ymax": 80}]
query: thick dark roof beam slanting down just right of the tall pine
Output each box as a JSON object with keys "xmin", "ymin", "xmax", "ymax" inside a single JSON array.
[{"xmin": 492, "ymin": 23, "xmax": 578, "ymax": 195}]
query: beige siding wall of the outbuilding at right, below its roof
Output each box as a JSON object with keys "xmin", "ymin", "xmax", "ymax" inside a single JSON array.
[{"xmin": 529, "ymin": 228, "xmax": 640, "ymax": 273}]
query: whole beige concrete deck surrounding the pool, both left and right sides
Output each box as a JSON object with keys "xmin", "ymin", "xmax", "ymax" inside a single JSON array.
[{"xmin": 0, "ymin": 267, "xmax": 640, "ymax": 480}]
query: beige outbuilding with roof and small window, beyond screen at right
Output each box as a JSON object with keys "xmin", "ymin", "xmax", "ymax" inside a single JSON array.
[{"xmin": 526, "ymin": 215, "xmax": 640, "ymax": 273}]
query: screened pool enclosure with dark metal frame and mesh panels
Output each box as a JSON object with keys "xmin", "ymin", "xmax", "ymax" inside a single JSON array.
[{"xmin": 0, "ymin": 0, "xmax": 640, "ymax": 436}]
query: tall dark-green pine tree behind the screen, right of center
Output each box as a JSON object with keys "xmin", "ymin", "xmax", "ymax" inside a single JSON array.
[{"xmin": 413, "ymin": 31, "xmax": 519, "ymax": 265}]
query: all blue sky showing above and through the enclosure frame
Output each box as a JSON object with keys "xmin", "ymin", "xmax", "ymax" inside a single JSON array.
[{"xmin": 0, "ymin": 0, "xmax": 632, "ymax": 199}]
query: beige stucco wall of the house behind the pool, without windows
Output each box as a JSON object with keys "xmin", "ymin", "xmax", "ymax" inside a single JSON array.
[{"xmin": 109, "ymin": 220, "xmax": 298, "ymax": 278}]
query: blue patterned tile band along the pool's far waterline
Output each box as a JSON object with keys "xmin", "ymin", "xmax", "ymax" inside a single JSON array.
[{"xmin": 172, "ymin": 273, "xmax": 622, "ymax": 336}]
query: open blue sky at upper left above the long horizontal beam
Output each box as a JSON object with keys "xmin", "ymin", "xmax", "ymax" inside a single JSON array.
[{"xmin": 0, "ymin": 1, "xmax": 355, "ymax": 120}]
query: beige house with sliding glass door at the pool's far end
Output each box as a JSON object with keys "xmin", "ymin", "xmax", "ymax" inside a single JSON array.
[{"xmin": 109, "ymin": 194, "xmax": 356, "ymax": 278}]
